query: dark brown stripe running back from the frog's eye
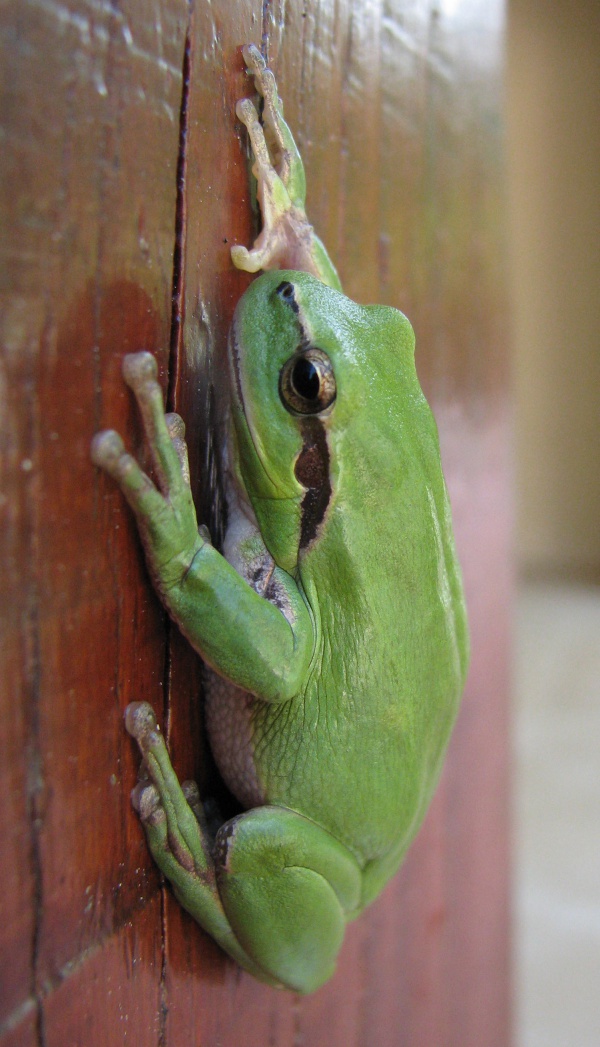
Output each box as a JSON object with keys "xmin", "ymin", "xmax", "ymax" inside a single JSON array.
[{"xmin": 294, "ymin": 418, "xmax": 331, "ymax": 549}]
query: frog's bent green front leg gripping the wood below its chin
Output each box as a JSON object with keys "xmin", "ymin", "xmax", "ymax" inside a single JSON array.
[{"xmin": 92, "ymin": 353, "xmax": 314, "ymax": 701}]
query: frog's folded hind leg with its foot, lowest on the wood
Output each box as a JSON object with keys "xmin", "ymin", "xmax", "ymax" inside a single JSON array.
[{"xmin": 126, "ymin": 703, "xmax": 361, "ymax": 993}]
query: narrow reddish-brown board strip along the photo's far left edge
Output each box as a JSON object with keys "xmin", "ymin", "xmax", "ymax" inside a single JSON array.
[{"xmin": 0, "ymin": 8, "xmax": 43, "ymax": 1021}]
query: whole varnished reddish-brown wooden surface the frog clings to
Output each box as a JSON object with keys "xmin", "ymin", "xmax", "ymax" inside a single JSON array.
[{"xmin": 0, "ymin": 0, "xmax": 510, "ymax": 1047}]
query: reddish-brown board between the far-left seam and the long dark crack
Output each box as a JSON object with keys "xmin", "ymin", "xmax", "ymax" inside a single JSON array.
[{"xmin": 37, "ymin": 0, "xmax": 183, "ymax": 979}]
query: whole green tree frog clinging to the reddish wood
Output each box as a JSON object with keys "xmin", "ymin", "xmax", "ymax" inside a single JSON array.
[{"xmin": 92, "ymin": 47, "xmax": 468, "ymax": 993}]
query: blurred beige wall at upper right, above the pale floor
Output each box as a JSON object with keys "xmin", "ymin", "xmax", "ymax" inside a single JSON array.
[{"xmin": 507, "ymin": 0, "xmax": 600, "ymax": 575}]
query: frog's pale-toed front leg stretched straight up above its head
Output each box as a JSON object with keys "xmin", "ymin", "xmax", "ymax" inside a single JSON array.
[{"xmin": 231, "ymin": 44, "xmax": 341, "ymax": 291}]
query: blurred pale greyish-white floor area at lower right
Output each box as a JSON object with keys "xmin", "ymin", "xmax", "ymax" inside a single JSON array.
[{"xmin": 514, "ymin": 584, "xmax": 600, "ymax": 1047}]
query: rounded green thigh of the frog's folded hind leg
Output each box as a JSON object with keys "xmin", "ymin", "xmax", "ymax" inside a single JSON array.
[{"xmin": 215, "ymin": 806, "xmax": 361, "ymax": 993}]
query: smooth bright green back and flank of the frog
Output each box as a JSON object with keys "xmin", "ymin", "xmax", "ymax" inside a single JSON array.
[{"xmin": 248, "ymin": 355, "xmax": 468, "ymax": 861}]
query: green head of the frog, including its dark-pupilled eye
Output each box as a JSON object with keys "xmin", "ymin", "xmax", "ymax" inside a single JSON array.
[{"xmin": 229, "ymin": 265, "xmax": 414, "ymax": 572}]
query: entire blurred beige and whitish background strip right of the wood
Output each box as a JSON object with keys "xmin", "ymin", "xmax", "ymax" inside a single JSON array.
[{"xmin": 506, "ymin": 0, "xmax": 600, "ymax": 1047}]
